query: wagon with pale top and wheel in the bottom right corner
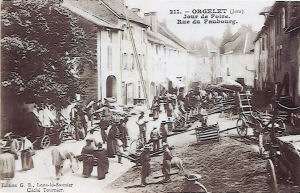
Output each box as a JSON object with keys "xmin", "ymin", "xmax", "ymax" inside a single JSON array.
[{"xmin": 267, "ymin": 135, "xmax": 300, "ymax": 192}]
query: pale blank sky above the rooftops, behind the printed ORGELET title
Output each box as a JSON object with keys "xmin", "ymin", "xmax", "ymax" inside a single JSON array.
[{"xmin": 125, "ymin": 0, "xmax": 274, "ymax": 42}]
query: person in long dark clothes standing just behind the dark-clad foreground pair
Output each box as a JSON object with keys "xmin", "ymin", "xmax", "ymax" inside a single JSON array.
[{"xmin": 107, "ymin": 123, "xmax": 120, "ymax": 158}]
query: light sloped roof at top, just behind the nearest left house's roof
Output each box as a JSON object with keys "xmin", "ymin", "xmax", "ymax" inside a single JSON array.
[{"xmin": 100, "ymin": 0, "xmax": 147, "ymax": 25}]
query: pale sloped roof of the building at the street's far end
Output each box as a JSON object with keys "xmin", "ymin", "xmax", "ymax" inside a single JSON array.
[{"xmin": 223, "ymin": 26, "xmax": 256, "ymax": 54}]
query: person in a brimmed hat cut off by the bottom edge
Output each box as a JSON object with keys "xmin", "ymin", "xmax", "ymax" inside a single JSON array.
[{"xmin": 182, "ymin": 174, "xmax": 207, "ymax": 192}]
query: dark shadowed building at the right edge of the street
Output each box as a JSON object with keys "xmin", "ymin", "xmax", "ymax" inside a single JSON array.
[{"xmin": 254, "ymin": 1, "xmax": 300, "ymax": 104}]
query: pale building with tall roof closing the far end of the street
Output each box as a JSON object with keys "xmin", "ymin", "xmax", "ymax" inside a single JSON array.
[{"xmin": 213, "ymin": 25, "xmax": 256, "ymax": 86}]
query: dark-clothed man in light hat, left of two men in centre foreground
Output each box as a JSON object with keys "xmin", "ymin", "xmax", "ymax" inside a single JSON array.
[{"xmin": 140, "ymin": 145, "xmax": 151, "ymax": 187}]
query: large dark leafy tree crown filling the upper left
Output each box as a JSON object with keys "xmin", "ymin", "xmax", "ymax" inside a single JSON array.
[{"xmin": 1, "ymin": 0, "xmax": 91, "ymax": 108}]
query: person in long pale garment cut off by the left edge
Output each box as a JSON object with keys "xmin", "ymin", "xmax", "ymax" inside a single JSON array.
[{"xmin": 0, "ymin": 146, "xmax": 15, "ymax": 180}]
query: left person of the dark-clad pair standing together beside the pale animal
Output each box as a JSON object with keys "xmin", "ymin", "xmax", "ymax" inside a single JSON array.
[{"xmin": 81, "ymin": 139, "xmax": 94, "ymax": 178}]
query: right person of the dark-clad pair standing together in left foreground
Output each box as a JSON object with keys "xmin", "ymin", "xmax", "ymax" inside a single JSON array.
[{"xmin": 94, "ymin": 143, "xmax": 109, "ymax": 180}]
